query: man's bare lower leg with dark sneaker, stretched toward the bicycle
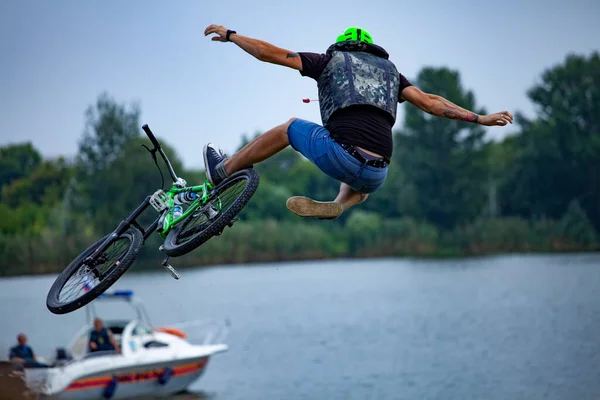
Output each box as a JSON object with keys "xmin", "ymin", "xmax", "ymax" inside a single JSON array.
[{"xmin": 204, "ymin": 118, "xmax": 295, "ymax": 185}]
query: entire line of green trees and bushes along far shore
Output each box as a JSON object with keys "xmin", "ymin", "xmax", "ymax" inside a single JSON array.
[{"xmin": 0, "ymin": 52, "xmax": 600, "ymax": 275}]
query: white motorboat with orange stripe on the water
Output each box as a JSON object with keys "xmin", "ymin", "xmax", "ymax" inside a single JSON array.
[{"xmin": 25, "ymin": 291, "xmax": 229, "ymax": 400}]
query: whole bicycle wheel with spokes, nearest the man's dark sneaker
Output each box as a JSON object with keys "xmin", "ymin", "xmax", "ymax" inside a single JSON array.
[{"xmin": 163, "ymin": 168, "xmax": 259, "ymax": 257}]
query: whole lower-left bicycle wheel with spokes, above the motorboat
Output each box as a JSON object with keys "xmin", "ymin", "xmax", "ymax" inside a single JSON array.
[{"xmin": 46, "ymin": 227, "xmax": 143, "ymax": 314}]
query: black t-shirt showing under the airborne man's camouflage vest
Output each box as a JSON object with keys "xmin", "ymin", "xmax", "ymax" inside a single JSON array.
[{"xmin": 298, "ymin": 52, "xmax": 412, "ymax": 159}]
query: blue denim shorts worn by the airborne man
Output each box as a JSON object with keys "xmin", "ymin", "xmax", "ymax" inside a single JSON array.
[{"xmin": 288, "ymin": 119, "xmax": 388, "ymax": 193}]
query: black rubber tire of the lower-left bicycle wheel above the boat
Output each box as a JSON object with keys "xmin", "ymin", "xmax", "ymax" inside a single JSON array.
[{"xmin": 46, "ymin": 227, "xmax": 143, "ymax": 314}]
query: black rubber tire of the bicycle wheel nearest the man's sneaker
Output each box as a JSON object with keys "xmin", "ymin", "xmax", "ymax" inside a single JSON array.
[{"xmin": 162, "ymin": 168, "xmax": 260, "ymax": 257}]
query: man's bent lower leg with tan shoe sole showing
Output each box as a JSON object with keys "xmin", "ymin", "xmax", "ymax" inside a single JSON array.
[{"xmin": 286, "ymin": 182, "xmax": 369, "ymax": 219}]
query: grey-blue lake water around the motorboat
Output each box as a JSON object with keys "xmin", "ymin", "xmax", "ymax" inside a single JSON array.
[{"xmin": 0, "ymin": 254, "xmax": 600, "ymax": 400}]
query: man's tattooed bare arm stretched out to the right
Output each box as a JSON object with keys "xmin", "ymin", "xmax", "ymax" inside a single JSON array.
[{"xmin": 401, "ymin": 86, "xmax": 513, "ymax": 126}]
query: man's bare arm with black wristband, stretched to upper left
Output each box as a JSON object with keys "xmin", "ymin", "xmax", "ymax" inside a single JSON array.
[{"xmin": 204, "ymin": 25, "xmax": 302, "ymax": 71}]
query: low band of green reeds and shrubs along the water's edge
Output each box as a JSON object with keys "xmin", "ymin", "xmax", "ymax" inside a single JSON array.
[{"xmin": 0, "ymin": 214, "xmax": 600, "ymax": 276}]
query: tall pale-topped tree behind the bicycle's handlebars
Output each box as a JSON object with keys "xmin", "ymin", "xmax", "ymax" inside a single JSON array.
[{"xmin": 68, "ymin": 94, "xmax": 184, "ymax": 234}]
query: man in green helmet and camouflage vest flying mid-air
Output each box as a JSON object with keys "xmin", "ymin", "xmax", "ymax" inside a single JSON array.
[{"xmin": 204, "ymin": 25, "xmax": 513, "ymax": 219}]
